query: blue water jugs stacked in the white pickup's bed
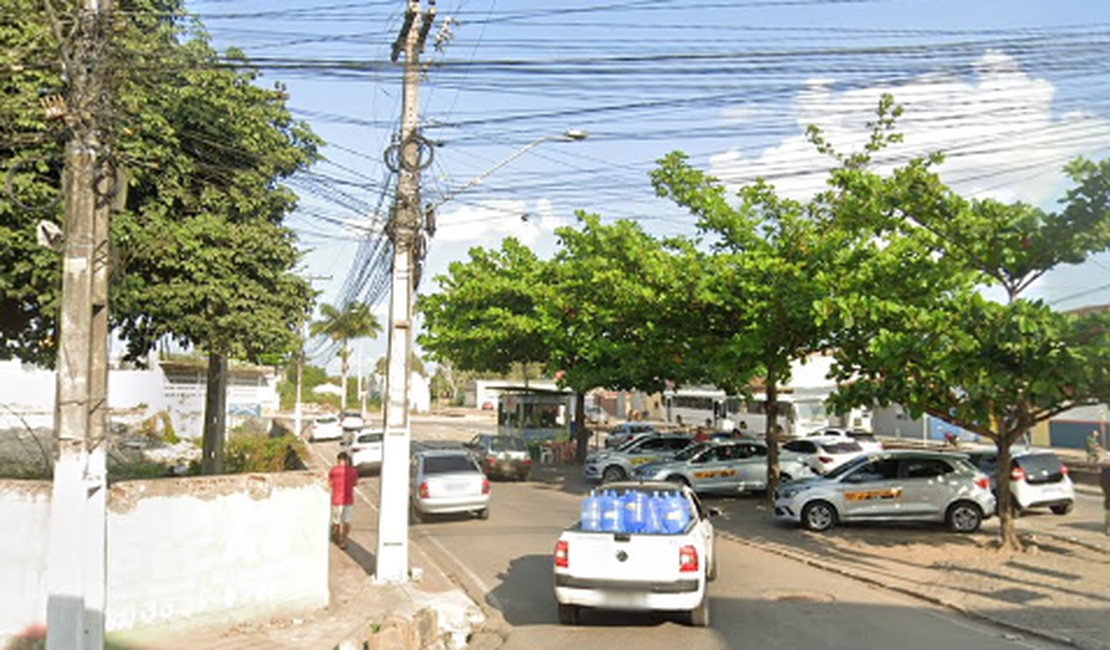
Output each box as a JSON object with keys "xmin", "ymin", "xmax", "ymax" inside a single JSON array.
[{"xmin": 582, "ymin": 489, "xmax": 690, "ymax": 535}]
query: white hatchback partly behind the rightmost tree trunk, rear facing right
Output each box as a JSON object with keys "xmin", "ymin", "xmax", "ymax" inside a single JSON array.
[{"xmin": 963, "ymin": 447, "xmax": 1076, "ymax": 515}]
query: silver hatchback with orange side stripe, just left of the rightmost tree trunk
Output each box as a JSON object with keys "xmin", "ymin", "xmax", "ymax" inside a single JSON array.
[{"xmin": 775, "ymin": 449, "xmax": 995, "ymax": 532}]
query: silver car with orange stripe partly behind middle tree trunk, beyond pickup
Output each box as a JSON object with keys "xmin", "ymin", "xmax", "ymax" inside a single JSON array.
[{"xmin": 634, "ymin": 440, "xmax": 814, "ymax": 494}]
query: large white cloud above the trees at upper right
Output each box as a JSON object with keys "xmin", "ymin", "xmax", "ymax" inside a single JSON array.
[{"xmin": 709, "ymin": 51, "xmax": 1110, "ymax": 205}]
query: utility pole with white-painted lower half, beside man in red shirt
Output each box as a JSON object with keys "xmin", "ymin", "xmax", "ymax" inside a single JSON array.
[{"xmin": 375, "ymin": 0, "xmax": 435, "ymax": 583}]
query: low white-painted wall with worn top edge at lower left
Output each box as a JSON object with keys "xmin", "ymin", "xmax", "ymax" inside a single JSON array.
[{"xmin": 0, "ymin": 471, "xmax": 329, "ymax": 643}]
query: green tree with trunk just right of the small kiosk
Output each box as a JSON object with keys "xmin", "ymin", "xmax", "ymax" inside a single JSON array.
[{"xmin": 539, "ymin": 212, "xmax": 698, "ymax": 463}]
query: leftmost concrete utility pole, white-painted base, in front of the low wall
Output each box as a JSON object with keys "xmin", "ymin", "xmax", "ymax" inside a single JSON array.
[{"xmin": 47, "ymin": 0, "xmax": 111, "ymax": 650}]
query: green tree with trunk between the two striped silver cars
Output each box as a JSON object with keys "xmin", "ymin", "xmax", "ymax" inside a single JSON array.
[{"xmin": 652, "ymin": 152, "xmax": 849, "ymax": 494}]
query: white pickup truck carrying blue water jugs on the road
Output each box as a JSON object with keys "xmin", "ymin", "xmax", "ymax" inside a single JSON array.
[{"xmin": 554, "ymin": 481, "xmax": 717, "ymax": 627}]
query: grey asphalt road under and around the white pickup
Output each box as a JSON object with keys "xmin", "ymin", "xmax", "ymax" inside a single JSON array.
[{"xmin": 308, "ymin": 420, "xmax": 1070, "ymax": 650}]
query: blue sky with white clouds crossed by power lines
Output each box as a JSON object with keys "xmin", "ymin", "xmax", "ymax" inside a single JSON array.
[{"xmin": 182, "ymin": 0, "xmax": 1110, "ymax": 363}]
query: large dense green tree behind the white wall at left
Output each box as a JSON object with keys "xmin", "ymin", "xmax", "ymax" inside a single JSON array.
[{"xmin": 0, "ymin": 0, "xmax": 319, "ymax": 470}]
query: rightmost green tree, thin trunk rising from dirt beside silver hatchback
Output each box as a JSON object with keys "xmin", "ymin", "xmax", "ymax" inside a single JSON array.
[{"xmin": 813, "ymin": 98, "xmax": 1110, "ymax": 548}]
